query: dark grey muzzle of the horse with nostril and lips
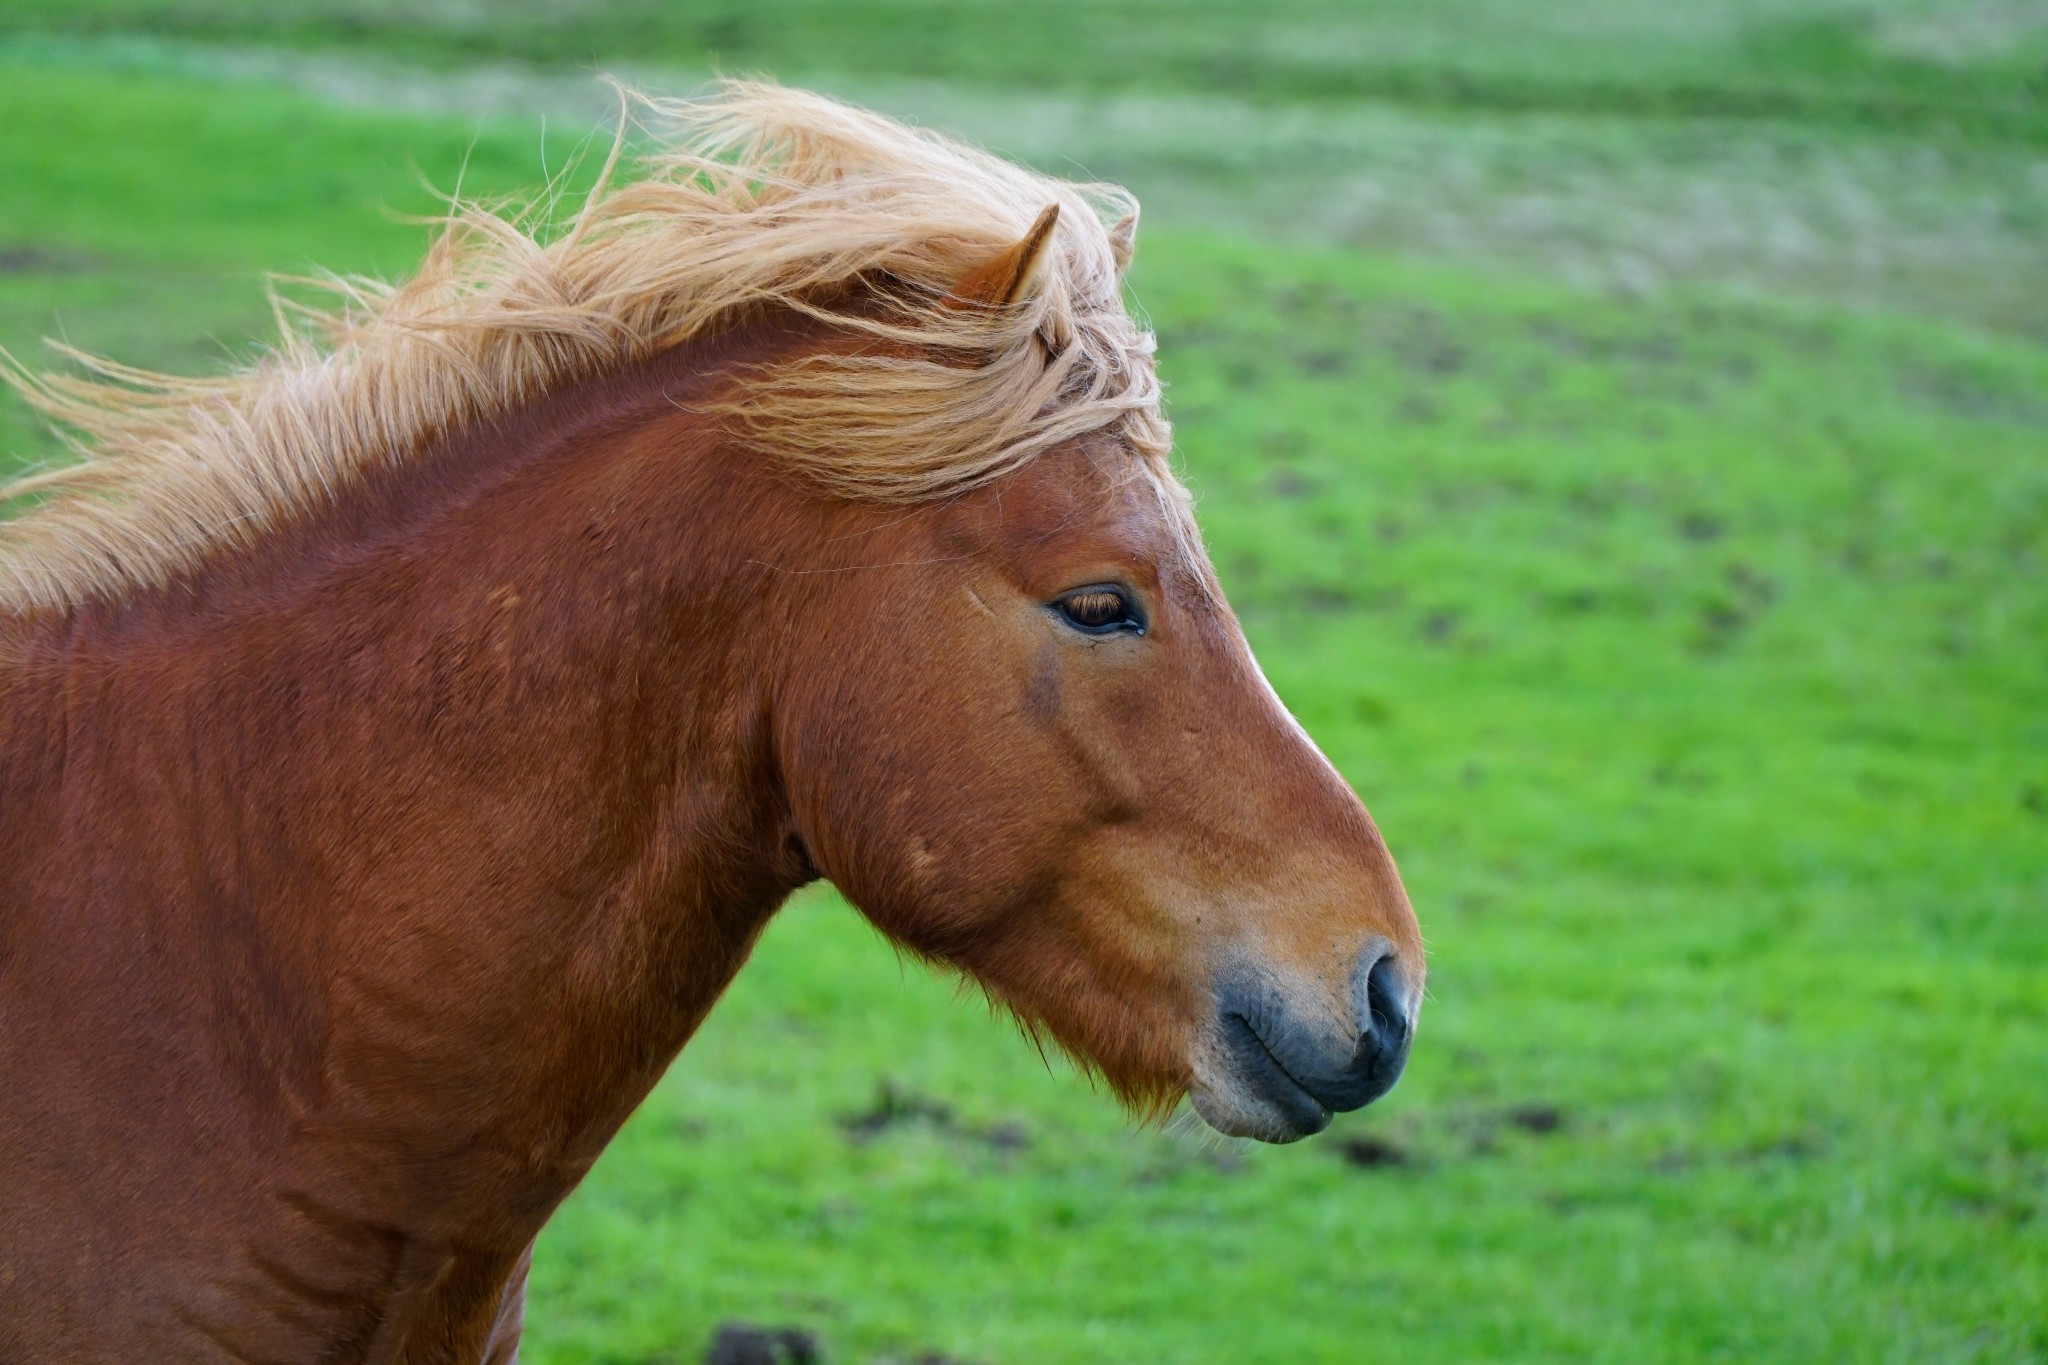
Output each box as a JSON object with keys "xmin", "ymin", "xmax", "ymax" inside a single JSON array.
[{"xmin": 1192, "ymin": 941, "xmax": 1415, "ymax": 1142}]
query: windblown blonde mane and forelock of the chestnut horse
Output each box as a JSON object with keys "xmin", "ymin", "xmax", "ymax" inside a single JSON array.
[{"xmin": 0, "ymin": 82, "xmax": 1169, "ymax": 614}]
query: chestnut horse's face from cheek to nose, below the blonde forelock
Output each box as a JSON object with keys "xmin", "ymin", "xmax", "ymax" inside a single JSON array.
[{"xmin": 780, "ymin": 438, "xmax": 1423, "ymax": 1142}]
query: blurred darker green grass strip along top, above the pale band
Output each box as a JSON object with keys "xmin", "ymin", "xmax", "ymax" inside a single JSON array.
[{"xmin": 0, "ymin": 0, "xmax": 2048, "ymax": 141}]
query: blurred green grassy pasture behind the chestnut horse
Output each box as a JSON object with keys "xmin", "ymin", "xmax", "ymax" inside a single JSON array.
[{"xmin": 0, "ymin": 0, "xmax": 2048, "ymax": 1365}]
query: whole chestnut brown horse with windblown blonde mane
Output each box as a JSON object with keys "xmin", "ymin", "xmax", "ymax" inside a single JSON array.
[{"xmin": 0, "ymin": 86, "xmax": 1423, "ymax": 1365}]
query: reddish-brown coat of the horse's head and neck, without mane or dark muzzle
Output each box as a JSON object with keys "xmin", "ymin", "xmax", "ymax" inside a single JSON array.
[{"xmin": 0, "ymin": 87, "xmax": 1421, "ymax": 1365}]
